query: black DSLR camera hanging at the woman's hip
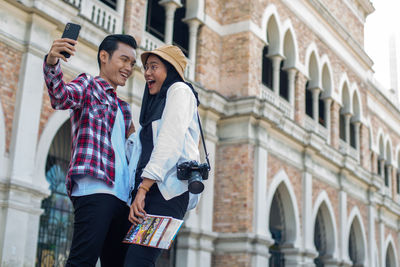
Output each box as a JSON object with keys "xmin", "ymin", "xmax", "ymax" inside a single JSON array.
[{"xmin": 176, "ymin": 161, "xmax": 210, "ymax": 194}]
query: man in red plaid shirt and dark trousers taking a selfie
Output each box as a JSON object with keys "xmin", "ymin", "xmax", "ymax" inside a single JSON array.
[{"xmin": 43, "ymin": 34, "xmax": 137, "ymax": 267}]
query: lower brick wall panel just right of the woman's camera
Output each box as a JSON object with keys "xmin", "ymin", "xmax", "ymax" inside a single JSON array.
[{"xmin": 213, "ymin": 144, "xmax": 254, "ymax": 233}]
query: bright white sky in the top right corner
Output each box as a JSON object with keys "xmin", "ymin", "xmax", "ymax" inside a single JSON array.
[{"xmin": 364, "ymin": 0, "xmax": 400, "ymax": 89}]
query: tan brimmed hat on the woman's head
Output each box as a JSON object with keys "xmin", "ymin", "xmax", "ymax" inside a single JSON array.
[{"xmin": 140, "ymin": 45, "xmax": 187, "ymax": 80}]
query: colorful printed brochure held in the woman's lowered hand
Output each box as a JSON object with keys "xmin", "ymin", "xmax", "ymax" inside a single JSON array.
[{"xmin": 122, "ymin": 214, "xmax": 183, "ymax": 249}]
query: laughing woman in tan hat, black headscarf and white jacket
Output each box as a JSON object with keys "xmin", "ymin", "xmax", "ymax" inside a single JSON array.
[{"xmin": 125, "ymin": 45, "xmax": 200, "ymax": 267}]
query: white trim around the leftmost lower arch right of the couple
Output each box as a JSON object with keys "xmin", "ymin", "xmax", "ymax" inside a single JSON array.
[{"xmin": 267, "ymin": 170, "xmax": 301, "ymax": 248}]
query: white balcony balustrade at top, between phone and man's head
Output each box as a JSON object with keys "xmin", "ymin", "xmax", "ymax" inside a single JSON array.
[{"xmin": 63, "ymin": 0, "xmax": 122, "ymax": 33}]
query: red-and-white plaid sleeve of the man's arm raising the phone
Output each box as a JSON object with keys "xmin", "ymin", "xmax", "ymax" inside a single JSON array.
[{"xmin": 43, "ymin": 58, "xmax": 91, "ymax": 109}]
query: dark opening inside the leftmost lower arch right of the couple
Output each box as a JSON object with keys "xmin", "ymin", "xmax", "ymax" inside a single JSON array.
[{"xmin": 269, "ymin": 191, "xmax": 286, "ymax": 267}]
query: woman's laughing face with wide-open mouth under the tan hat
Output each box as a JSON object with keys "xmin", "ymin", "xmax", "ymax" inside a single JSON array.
[{"xmin": 144, "ymin": 55, "xmax": 167, "ymax": 95}]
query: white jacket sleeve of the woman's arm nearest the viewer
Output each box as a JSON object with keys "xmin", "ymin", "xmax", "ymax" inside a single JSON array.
[{"xmin": 142, "ymin": 83, "xmax": 196, "ymax": 182}]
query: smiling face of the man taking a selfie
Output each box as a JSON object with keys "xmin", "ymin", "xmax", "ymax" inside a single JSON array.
[{"xmin": 100, "ymin": 42, "xmax": 136, "ymax": 89}]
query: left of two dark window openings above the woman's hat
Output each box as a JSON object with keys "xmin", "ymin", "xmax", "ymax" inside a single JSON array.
[{"xmin": 146, "ymin": 0, "xmax": 165, "ymax": 41}]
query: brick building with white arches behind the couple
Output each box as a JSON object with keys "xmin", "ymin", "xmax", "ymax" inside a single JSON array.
[{"xmin": 0, "ymin": 0, "xmax": 400, "ymax": 267}]
